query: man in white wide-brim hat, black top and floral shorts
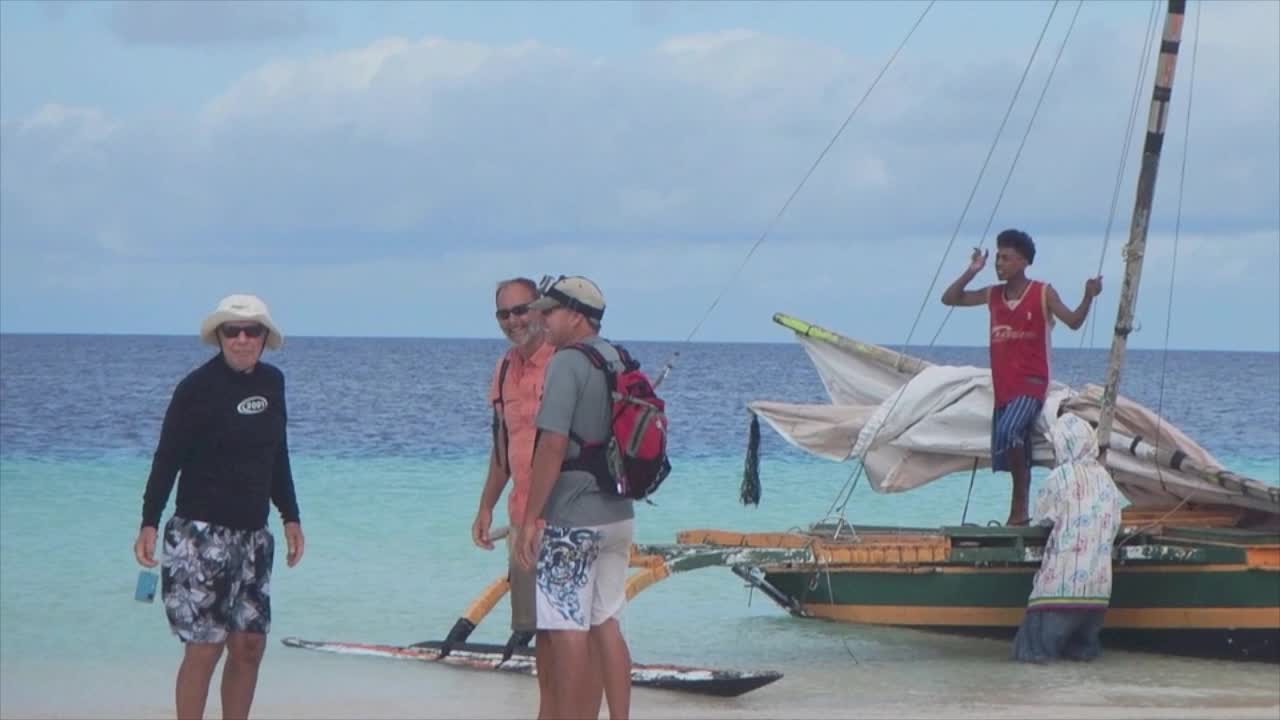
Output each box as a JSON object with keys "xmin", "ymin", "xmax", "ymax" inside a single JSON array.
[{"xmin": 133, "ymin": 295, "xmax": 305, "ymax": 717}]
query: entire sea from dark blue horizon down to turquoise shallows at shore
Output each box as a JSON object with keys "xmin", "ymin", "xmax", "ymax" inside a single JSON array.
[{"xmin": 0, "ymin": 336, "xmax": 1280, "ymax": 716}]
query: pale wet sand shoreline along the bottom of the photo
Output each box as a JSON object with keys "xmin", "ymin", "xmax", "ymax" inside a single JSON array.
[{"xmin": 0, "ymin": 638, "xmax": 1280, "ymax": 720}]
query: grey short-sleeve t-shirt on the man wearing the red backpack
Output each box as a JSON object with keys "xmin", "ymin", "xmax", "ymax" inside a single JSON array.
[{"xmin": 538, "ymin": 336, "xmax": 635, "ymax": 528}]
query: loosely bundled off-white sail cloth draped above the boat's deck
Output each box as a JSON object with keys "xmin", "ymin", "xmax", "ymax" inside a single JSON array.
[{"xmin": 749, "ymin": 334, "xmax": 1277, "ymax": 512}]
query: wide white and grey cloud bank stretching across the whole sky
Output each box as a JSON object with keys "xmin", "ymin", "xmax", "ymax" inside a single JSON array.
[{"xmin": 0, "ymin": 3, "xmax": 1280, "ymax": 341}]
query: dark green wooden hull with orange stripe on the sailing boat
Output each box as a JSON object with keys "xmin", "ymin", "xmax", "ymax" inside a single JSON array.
[{"xmin": 762, "ymin": 532, "xmax": 1280, "ymax": 662}]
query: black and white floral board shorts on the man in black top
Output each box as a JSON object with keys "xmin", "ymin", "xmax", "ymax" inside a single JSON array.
[{"xmin": 160, "ymin": 516, "xmax": 275, "ymax": 643}]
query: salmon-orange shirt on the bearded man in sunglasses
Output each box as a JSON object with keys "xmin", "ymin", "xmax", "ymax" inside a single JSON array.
[{"xmin": 489, "ymin": 342, "xmax": 556, "ymax": 525}]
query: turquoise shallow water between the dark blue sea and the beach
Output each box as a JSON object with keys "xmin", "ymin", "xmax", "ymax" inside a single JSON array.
[{"xmin": 0, "ymin": 456, "xmax": 1280, "ymax": 717}]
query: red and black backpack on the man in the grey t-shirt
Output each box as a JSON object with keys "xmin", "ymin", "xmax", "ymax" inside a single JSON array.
[{"xmin": 561, "ymin": 342, "xmax": 671, "ymax": 500}]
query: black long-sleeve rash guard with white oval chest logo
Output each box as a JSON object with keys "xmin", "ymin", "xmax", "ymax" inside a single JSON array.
[{"xmin": 142, "ymin": 355, "xmax": 298, "ymax": 530}]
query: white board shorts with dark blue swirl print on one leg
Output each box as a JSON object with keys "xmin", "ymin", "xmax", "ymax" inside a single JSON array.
[{"xmin": 535, "ymin": 519, "xmax": 635, "ymax": 630}]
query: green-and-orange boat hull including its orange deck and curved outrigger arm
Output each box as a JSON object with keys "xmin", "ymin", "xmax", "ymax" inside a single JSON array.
[{"xmin": 650, "ymin": 512, "xmax": 1280, "ymax": 662}]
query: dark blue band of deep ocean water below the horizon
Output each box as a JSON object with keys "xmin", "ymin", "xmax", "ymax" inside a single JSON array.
[{"xmin": 0, "ymin": 336, "xmax": 1280, "ymax": 462}]
